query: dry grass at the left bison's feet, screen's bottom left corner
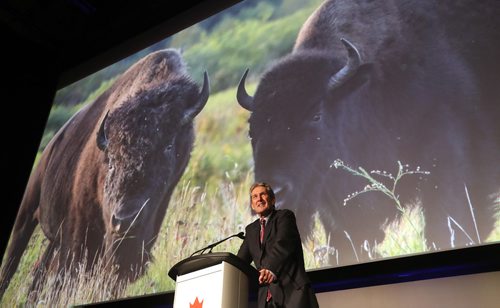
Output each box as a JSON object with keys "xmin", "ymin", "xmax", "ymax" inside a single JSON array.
[{"xmin": 1, "ymin": 233, "xmax": 127, "ymax": 307}]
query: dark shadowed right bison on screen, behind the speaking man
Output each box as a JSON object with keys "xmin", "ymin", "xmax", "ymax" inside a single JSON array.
[{"xmin": 237, "ymin": 0, "xmax": 500, "ymax": 265}]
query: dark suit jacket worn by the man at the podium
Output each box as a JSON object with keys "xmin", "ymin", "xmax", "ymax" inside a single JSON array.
[{"xmin": 238, "ymin": 210, "xmax": 318, "ymax": 308}]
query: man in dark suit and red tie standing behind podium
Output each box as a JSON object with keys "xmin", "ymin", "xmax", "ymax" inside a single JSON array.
[{"xmin": 238, "ymin": 183, "xmax": 318, "ymax": 308}]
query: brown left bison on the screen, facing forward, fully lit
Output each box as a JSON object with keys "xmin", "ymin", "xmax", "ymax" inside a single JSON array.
[{"xmin": 0, "ymin": 49, "xmax": 209, "ymax": 294}]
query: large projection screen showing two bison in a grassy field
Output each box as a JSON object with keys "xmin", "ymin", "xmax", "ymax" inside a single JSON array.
[{"xmin": 1, "ymin": 0, "xmax": 500, "ymax": 306}]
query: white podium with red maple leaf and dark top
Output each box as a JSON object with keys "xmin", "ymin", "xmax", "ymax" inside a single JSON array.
[{"xmin": 168, "ymin": 252, "xmax": 258, "ymax": 308}]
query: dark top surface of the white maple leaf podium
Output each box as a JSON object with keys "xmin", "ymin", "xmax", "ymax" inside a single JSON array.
[{"xmin": 168, "ymin": 252, "xmax": 258, "ymax": 280}]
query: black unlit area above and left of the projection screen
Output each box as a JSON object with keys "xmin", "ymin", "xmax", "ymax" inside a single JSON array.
[{"xmin": 0, "ymin": 0, "xmax": 239, "ymax": 262}]
